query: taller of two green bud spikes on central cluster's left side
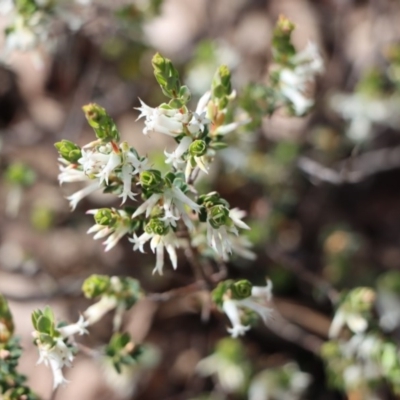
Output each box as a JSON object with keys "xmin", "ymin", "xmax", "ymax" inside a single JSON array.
[{"xmin": 82, "ymin": 103, "xmax": 120, "ymax": 142}]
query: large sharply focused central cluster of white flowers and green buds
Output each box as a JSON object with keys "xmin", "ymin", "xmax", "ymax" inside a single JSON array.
[{"xmin": 55, "ymin": 54, "xmax": 253, "ymax": 274}]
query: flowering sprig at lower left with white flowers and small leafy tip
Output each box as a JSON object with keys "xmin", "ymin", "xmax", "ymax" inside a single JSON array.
[{"xmin": 32, "ymin": 275, "xmax": 142, "ymax": 388}]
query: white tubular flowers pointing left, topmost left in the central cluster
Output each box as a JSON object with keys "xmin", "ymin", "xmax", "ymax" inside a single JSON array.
[{"xmin": 137, "ymin": 100, "xmax": 188, "ymax": 136}]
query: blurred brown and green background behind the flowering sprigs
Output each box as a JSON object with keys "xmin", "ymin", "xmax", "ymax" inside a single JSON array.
[{"xmin": 0, "ymin": 0, "xmax": 400, "ymax": 400}]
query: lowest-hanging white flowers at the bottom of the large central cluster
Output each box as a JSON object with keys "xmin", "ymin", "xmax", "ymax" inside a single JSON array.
[{"xmin": 129, "ymin": 232, "xmax": 179, "ymax": 275}]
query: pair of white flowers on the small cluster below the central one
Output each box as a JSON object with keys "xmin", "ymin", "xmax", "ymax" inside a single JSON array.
[{"xmin": 222, "ymin": 280, "xmax": 272, "ymax": 338}]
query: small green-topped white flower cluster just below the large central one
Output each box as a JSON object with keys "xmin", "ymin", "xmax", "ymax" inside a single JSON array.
[{"xmin": 212, "ymin": 279, "xmax": 272, "ymax": 338}]
